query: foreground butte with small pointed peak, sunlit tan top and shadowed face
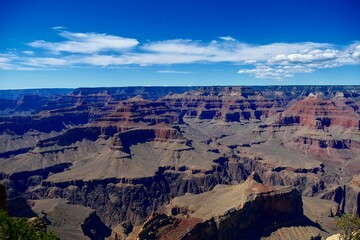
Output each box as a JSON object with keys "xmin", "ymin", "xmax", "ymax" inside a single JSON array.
[{"xmin": 137, "ymin": 174, "xmax": 312, "ymax": 239}]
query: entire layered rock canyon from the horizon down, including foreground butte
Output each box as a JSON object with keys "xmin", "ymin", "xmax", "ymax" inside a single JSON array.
[{"xmin": 0, "ymin": 86, "xmax": 360, "ymax": 240}]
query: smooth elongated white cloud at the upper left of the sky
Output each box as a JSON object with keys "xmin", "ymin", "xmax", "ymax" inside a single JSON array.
[{"xmin": 29, "ymin": 31, "xmax": 139, "ymax": 54}]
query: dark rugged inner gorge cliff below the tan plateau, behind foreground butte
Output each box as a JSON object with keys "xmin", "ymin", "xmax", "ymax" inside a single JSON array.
[{"xmin": 11, "ymin": 156, "xmax": 328, "ymax": 229}]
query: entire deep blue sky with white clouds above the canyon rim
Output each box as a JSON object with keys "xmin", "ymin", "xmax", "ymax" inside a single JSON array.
[{"xmin": 0, "ymin": 0, "xmax": 360, "ymax": 89}]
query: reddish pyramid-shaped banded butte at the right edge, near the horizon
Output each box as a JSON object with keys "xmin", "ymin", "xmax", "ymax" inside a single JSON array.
[{"xmin": 271, "ymin": 93, "xmax": 360, "ymax": 161}]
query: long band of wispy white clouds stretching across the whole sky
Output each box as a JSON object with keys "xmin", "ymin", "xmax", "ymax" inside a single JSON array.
[{"xmin": 0, "ymin": 26, "xmax": 360, "ymax": 80}]
